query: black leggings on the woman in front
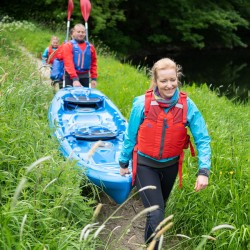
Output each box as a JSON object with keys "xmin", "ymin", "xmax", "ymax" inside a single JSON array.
[{"xmin": 135, "ymin": 162, "xmax": 178, "ymax": 249}]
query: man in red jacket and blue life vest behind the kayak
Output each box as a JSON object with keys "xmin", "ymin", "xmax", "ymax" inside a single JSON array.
[{"xmin": 63, "ymin": 24, "xmax": 97, "ymax": 88}]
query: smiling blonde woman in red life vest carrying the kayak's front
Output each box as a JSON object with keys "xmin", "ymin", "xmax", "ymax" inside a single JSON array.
[{"xmin": 119, "ymin": 58, "xmax": 211, "ymax": 249}]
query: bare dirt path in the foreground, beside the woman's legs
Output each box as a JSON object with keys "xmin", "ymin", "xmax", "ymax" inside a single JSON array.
[{"xmin": 97, "ymin": 191, "xmax": 146, "ymax": 250}]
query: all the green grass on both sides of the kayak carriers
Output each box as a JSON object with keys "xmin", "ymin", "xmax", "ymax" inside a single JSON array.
[{"xmin": 0, "ymin": 19, "xmax": 250, "ymax": 250}]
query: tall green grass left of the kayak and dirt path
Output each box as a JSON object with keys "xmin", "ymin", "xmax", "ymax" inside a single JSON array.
[{"xmin": 0, "ymin": 18, "xmax": 98, "ymax": 249}]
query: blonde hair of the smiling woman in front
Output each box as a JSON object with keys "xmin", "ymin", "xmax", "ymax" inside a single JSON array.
[{"xmin": 149, "ymin": 58, "xmax": 183, "ymax": 89}]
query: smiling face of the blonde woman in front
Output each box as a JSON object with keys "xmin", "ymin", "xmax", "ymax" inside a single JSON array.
[{"xmin": 156, "ymin": 68, "xmax": 178, "ymax": 99}]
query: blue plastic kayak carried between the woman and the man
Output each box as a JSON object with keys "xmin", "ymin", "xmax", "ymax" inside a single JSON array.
[{"xmin": 48, "ymin": 87, "xmax": 132, "ymax": 204}]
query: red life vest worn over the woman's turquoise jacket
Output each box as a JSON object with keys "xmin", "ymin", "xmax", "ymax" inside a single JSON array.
[{"xmin": 133, "ymin": 90, "xmax": 194, "ymax": 186}]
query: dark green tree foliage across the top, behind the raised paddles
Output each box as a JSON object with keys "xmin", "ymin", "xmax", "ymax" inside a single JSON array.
[{"xmin": 0, "ymin": 0, "xmax": 250, "ymax": 55}]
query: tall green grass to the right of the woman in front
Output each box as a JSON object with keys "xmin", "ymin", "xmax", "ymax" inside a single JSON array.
[{"xmin": 163, "ymin": 85, "xmax": 250, "ymax": 249}]
